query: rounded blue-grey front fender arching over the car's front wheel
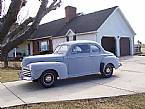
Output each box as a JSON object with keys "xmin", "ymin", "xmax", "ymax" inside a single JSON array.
[{"xmin": 31, "ymin": 62, "xmax": 68, "ymax": 80}]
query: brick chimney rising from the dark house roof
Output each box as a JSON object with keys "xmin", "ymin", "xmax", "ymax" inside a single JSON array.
[{"xmin": 65, "ymin": 6, "xmax": 77, "ymax": 23}]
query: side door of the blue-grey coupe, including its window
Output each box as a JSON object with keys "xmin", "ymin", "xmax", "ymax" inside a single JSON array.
[{"xmin": 68, "ymin": 44, "xmax": 91, "ymax": 77}]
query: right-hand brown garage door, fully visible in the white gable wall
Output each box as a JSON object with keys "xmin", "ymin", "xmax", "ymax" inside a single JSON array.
[{"xmin": 120, "ymin": 38, "xmax": 130, "ymax": 56}]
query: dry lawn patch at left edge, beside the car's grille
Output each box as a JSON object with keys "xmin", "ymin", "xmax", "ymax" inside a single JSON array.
[{"xmin": 0, "ymin": 68, "xmax": 20, "ymax": 82}]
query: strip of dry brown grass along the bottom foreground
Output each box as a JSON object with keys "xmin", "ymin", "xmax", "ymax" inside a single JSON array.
[{"xmin": 4, "ymin": 93, "xmax": 145, "ymax": 109}]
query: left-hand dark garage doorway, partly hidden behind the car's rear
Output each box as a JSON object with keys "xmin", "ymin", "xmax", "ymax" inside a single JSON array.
[{"xmin": 101, "ymin": 37, "xmax": 116, "ymax": 54}]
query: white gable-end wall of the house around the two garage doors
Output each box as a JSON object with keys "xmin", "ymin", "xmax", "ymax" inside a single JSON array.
[{"xmin": 97, "ymin": 9, "xmax": 134, "ymax": 57}]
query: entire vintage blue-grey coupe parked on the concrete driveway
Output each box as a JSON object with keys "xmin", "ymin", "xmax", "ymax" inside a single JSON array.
[{"xmin": 20, "ymin": 41, "xmax": 121, "ymax": 87}]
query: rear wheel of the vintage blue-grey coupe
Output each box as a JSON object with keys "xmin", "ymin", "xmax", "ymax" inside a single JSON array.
[{"xmin": 101, "ymin": 64, "xmax": 113, "ymax": 78}]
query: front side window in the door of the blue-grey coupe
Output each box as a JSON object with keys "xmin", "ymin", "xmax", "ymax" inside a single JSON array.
[{"xmin": 72, "ymin": 44, "xmax": 90, "ymax": 54}]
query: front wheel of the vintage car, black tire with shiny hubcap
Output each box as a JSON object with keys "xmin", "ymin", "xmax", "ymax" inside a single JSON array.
[{"xmin": 38, "ymin": 70, "xmax": 57, "ymax": 88}]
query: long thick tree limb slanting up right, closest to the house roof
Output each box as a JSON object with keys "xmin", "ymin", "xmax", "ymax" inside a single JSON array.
[{"xmin": 2, "ymin": 0, "xmax": 61, "ymax": 53}]
